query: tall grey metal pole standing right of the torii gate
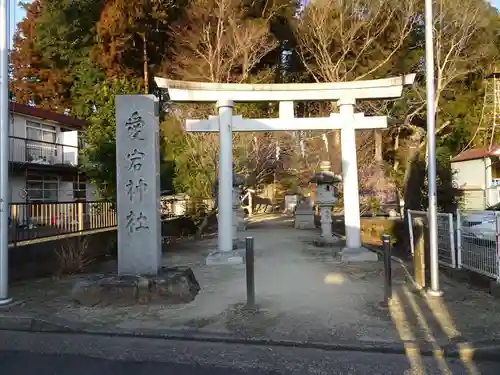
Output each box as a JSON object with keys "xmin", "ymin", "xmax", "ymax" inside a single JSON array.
[{"xmin": 425, "ymin": 0, "xmax": 442, "ymax": 297}]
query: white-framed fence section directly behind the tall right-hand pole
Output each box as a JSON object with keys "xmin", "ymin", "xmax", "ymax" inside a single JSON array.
[{"xmin": 407, "ymin": 210, "xmax": 457, "ymax": 268}]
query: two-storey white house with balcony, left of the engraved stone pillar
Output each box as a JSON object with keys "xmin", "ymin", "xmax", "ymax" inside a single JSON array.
[{"xmin": 9, "ymin": 102, "xmax": 97, "ymax": 203}]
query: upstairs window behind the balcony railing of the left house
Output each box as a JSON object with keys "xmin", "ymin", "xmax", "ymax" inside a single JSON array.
[{"xmin": 26, "ymin": 120, "xmax": 57, "ymax": 164}]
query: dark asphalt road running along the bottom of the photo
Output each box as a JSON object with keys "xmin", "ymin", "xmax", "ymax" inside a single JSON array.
[{"xmin": 0, "ymin": 331, "xmax": 500, "ymax": 375}]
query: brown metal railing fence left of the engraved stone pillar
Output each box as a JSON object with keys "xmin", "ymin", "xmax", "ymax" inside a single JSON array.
[{"xmin": 9, "ymin": 201, "xmax": 117, "ymax": 243}]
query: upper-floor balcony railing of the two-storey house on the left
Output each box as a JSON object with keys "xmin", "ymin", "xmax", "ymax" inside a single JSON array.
[{"xmin": 9, "ymin": 136, "xmax": 78, "ymax": 166}]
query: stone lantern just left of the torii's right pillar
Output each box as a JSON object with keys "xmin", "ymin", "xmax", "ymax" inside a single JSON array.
[{"xmin": 310, "ymin": 162, "xmax": 341, "ymax": 246}]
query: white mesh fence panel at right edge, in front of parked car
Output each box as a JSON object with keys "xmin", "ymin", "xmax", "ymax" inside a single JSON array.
[{"xmin": 457, "ymin": 211, "xmax": 500, "ymax": 279}]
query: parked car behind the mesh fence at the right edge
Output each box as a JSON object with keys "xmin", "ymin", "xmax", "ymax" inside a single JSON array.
[{"xmin": 461, "ymin": 203, "xmax": 500, "ymax": 244}]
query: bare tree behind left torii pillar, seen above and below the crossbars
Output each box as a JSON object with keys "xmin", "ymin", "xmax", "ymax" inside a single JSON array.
[{"xmin": 162, "ymin": 0, "xmax": 292, "ymax": 233}]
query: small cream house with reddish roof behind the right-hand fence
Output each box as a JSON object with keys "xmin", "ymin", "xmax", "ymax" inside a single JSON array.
[{"xmin": 451, "ymin": 146, "xmax": 500, "ymax": 210}]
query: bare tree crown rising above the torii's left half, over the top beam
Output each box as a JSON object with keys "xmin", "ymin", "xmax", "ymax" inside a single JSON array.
[{"xmin": 164, "ymin": 0, "xmax": 284, "ymax": 83}]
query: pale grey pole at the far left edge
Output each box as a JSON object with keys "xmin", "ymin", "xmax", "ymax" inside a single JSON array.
[{"xmin": 0, "ymin": 0, "xmax": 12, "ymax": 306}]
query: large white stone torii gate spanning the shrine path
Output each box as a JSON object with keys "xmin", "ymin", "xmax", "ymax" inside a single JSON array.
[{"xmin": 155, "ymin": 74, "xmax": 415, "ymax": 260}]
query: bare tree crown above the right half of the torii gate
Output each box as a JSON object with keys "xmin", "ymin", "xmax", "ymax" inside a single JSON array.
[{"xmin": 296, "ymin": 0, "xmax": 418, "ymax": 82}]
